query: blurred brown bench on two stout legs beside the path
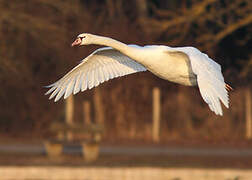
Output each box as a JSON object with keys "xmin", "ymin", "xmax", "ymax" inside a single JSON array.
[{"xmin": 45, "ymin": 122, "xmax": 104, "ymax": 162}]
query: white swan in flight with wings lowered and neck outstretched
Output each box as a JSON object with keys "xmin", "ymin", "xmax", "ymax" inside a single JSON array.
[{"xmin": 45, "ymin": 33, "xmax": 232, "ymax": 116}]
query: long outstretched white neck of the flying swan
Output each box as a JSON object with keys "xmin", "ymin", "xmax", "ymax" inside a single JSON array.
[{"xmin": 93, "ymin": 36, "xmax": 139, "ymax": 61}]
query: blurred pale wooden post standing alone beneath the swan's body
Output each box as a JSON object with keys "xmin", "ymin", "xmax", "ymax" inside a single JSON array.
[{"xmin": 152, "ymin": 87, "xmax": 161, "ymax": 142}]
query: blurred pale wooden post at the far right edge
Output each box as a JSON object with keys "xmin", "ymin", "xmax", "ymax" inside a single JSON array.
[{"xmin": 245, "ymin": 88, "xmax": 252, "ymax": 139}]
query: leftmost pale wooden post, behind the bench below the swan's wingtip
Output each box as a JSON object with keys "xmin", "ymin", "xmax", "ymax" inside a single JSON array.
[{"xmin": 65, "ymin": 95, "xmax": 74, "ymax": 140}]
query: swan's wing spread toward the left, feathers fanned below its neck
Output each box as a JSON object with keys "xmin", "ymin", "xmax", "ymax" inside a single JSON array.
[{"xmin": 46, "ymin": 47, "xmax": 146, "ymax": 102}]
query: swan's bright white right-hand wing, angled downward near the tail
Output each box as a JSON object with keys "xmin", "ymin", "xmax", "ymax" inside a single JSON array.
[{"xmin": 179, "ymin": 48, "xmax": 229, "ymax": 115}]
